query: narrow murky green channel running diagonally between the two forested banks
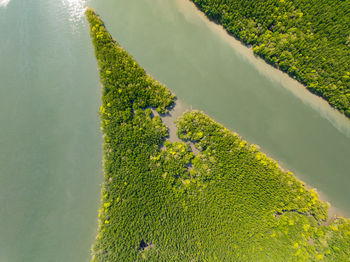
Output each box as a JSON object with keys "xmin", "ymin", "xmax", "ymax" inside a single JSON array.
[{"xmin": 92, "ymin": 0, "xmax": 350, "ymax": 215}]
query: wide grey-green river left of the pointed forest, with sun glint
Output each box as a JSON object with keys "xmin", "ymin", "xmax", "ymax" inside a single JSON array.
[{"xmin": 0, "ymin": 0, "xmax": 103, "ymax": 262}]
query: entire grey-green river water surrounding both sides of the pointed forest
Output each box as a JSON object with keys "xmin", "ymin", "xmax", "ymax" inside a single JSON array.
[{"xmin": 0, "ymin": 0, "xmax": 350, "ymax": 262}]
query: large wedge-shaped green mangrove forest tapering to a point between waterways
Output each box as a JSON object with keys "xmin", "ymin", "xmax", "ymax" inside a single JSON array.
[{"xmin": 86, "ymin": 9, "xmax": 350, "ymax": 262}]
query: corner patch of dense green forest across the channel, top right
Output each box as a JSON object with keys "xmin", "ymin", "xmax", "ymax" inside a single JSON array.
[{"xmin": 192, "ymin": 0, "xmax": 350, "ymax": 117}]
